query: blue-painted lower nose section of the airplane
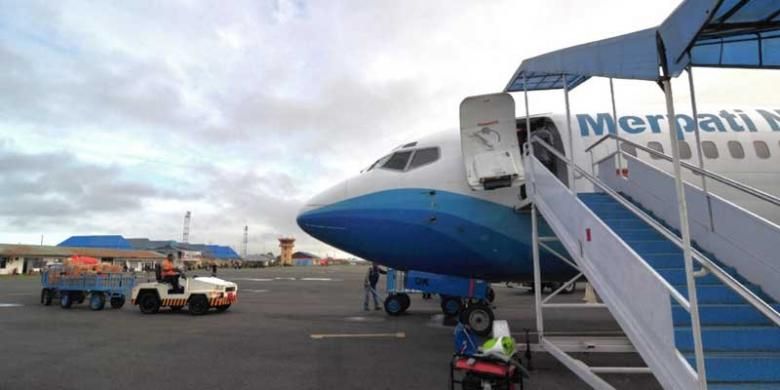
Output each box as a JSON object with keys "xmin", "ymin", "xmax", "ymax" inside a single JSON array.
[{"xmin": 298, "ymin": 188, "xmax": 575, "ymax": 281}]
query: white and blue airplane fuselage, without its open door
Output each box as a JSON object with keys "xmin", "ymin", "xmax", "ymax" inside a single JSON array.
[{"xmin": 298, "ymin": 109, "xmax": 780, "ymax": 280}]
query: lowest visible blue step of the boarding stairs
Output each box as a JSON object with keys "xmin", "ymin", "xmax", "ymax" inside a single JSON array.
[{"xmin": 685, "ymin": 353, "xmax": 780, "ymax": 382}]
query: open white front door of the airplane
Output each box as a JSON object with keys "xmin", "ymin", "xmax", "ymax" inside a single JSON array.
[{"xmin": 460, "ymin": 93, "xmax": 525, "ymax": 191}]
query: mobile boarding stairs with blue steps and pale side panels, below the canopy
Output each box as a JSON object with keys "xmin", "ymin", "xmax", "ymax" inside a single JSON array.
[{"xmin": 523, "ymin": 135, "xmax": 780, "ymax": 389}]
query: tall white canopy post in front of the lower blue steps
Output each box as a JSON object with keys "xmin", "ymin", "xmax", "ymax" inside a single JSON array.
[{"xmin": 663, "ymin": 77, "xmax": 707, "ymax": 390}]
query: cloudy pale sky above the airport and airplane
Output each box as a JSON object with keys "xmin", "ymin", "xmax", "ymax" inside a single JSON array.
[{"xmin": 0, "ymin": 0, "xmax": 780, "ymax": 256}]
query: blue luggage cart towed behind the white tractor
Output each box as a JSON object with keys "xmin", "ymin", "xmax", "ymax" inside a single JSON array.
[{"xmin": 41, "ymin": 270, "xmax": 135, "ymax": 310}]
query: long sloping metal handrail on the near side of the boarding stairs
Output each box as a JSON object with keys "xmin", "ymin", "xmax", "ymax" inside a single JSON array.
[{"xmin": 532, "ymin": 137, "xmax": 780, "ymax": 326}]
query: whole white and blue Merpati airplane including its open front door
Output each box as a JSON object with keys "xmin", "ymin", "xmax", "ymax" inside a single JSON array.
[{"xmin": 297, "ymin": 93, "xmax": 780, "ymax": 283}]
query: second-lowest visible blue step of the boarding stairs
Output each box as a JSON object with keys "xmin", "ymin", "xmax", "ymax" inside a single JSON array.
[{"xmin": 674, "ymin": 326, "xmax": 780, "ymax": 354}]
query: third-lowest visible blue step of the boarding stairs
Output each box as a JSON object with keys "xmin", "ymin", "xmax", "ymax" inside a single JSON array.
[{"xmin": 672, "ymin": 304, "xmax": 780, "ymax": 326}]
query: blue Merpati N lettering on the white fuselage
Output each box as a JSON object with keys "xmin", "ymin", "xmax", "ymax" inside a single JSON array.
[{"xmin": 577, "ymin": 109, "xmax": 780, "ymax": 139}]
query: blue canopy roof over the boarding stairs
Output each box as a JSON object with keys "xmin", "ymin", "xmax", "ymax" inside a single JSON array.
[{"xmin": 505, "ymin": 0, "xmax": 780, "ymax": 92}]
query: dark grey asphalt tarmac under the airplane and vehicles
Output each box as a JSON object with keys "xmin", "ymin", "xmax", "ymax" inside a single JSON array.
[{"xmin": 0, "ymin": 266, "xmax": 660, "ymax": 390}]
